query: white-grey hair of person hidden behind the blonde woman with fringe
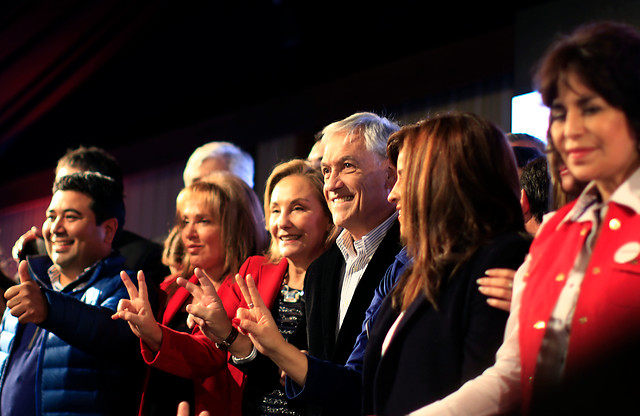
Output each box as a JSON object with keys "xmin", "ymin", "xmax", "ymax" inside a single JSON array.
[{"xmin": 182, "ymin": 142, "xmax": 255, "ymax": 188}]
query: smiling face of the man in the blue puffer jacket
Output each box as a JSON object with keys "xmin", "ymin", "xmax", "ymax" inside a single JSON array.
[{"xmin": 42, "ymin": 191, "xmax": 117, "ymax": 280}]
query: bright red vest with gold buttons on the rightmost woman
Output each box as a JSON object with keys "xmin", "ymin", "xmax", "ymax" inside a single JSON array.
[{"xmin": 519, "ymin": 202, "xmax": 640, "ymax": 409}]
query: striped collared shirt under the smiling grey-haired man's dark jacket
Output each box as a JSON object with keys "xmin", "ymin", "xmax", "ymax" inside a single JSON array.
[{"xmin": 336, "ymin": 212, "xmax": 398, "ymax": 337}]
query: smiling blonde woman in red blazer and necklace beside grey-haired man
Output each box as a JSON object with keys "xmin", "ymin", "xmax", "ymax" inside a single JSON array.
[{"xmin": 158, "ymin": 160, "xmax": 336, "ymax": 415}]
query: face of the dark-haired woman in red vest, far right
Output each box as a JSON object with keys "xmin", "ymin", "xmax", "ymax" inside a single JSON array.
[{"xmin": 549, "ymin": 73, "xmax": 640, "ymax": 200}]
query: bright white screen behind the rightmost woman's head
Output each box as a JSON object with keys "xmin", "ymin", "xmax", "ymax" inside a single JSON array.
[{"xmin": 511, "ymin": 91, "xmax": 549, "ymax": 143}]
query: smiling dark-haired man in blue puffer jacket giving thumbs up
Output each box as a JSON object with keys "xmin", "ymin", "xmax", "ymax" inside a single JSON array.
[{"xmin": 0, "ymin": 172, "xmax": 152, "ymax": 416}]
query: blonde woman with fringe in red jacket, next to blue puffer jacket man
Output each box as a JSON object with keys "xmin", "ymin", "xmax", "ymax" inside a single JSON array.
[{"xmin": 117, "ymin": 173, "xmax": 267, "ymax": 416}]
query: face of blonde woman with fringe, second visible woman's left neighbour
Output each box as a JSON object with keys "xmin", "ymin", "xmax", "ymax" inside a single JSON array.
[{"xmin": 180, "ymin": 199, "xmax": 225, "ymax": 280}]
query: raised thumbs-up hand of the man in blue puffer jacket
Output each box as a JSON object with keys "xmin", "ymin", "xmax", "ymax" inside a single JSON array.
[{"xmin": 4, "ymin": 260, "xmax": 49, "ymax": 324}]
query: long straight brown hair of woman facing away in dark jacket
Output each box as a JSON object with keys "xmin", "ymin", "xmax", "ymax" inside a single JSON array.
[{"xmin": 387, "ymin": 112, "xmax": 524, "ymax": 309}]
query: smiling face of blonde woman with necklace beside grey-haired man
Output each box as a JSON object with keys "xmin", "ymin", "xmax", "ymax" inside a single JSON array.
[{"xmin": 268, "ymin": 175, "xmax": 331, "ymax": 269}]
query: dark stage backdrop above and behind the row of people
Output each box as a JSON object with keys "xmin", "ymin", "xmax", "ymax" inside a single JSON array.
[{"xmin": 0, "ymin": 0, "xmax": 640, "ymax": 276}]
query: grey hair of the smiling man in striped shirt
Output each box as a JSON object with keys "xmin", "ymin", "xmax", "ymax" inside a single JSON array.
[{"xmin": 322, "ymin": 112, "xmax": 400, "ymax": 159}]
